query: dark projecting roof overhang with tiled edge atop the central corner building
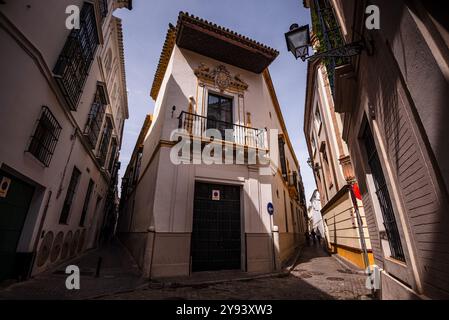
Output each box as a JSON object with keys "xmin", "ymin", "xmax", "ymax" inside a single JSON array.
[{"xmin": 176, "ymin": 12, "xmax": 279, "ymax": 73}]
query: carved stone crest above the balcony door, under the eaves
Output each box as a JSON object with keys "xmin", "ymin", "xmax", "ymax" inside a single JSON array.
[{"xmin": 194, "ymin": 63, "xmax": 248, "ymax": 91}]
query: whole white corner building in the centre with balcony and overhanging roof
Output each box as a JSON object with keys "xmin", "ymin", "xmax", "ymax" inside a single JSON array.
[{"xmin": 118, "ymin": 12, "xmax": 307, "ymax": 278}]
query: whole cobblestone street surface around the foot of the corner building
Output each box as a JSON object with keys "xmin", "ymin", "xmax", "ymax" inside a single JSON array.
[{"xmin": 0, "ymin": 243, "xmax": 370, "ymax": 300}]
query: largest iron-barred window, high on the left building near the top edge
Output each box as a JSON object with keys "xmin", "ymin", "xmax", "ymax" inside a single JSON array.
[{"xmin": 53, "ymin": 2, "xmax": 99, "ymax": 110}]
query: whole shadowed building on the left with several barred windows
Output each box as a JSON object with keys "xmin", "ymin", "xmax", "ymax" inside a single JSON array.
[{"xmin": 0, "ymin": 0, "xmax": 131, "ymax": 280}]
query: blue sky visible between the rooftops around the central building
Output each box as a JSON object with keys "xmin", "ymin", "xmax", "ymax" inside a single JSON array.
[{"xmin": 114, "ymin": 0, "xmax": 316, "ymax": 202}]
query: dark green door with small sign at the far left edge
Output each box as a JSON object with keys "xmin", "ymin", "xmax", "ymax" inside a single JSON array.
[{"xmin": 0, "ymin": 170, "xmax": 34, "ymax": 281}]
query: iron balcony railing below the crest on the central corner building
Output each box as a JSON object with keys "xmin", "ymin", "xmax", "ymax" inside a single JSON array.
[{"xmin": 178, "ymin": 111, "xmax": 268, "ymax": 149}]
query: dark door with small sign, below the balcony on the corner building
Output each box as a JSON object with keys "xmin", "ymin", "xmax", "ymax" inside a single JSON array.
[{"xmin": 191, "ymin": 182, "xmax": 241, "ymax": 272}]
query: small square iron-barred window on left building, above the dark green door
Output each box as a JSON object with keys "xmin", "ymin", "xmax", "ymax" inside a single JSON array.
[{"xmin": 27, "ymin": 106, "xmax": 62, "ymax": 167}]
